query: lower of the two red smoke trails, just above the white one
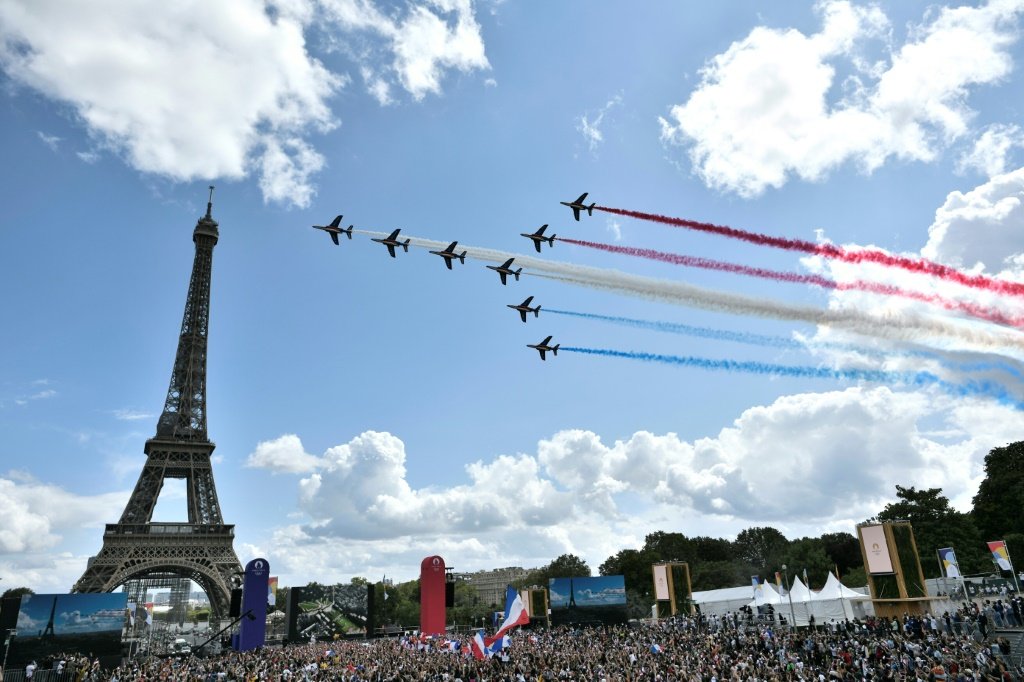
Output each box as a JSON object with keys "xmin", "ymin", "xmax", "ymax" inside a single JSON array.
[{"xmin": 556, "ymin": 237, "xmax": 1024, "ymax": 328}]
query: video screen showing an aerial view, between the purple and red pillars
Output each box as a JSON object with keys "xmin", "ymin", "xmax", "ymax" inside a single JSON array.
[{"xmin": 288, "ymin": 583, "xmax": 373, "ymax": 641}]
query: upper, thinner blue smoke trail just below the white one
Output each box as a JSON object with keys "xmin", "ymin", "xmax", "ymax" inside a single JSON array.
[{"xmin": 544, "ymin": 308, "xmax": 1024, "ymax": 379}]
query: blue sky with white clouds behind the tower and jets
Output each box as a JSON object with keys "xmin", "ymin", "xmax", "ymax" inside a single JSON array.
[{"xmin": 0, "ymin": 0, "xmax": 1024, "ymax": 591}]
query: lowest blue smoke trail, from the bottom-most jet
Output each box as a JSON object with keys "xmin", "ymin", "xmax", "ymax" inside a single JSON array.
[{"xmin": 561, "ymin": 346, "xmax": 1024, "ymax": 411}]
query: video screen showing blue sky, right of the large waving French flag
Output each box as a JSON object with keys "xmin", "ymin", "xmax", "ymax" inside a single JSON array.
[{"xmin": 548, "ymin": 576, "xmax": 629, "ymax": 626}]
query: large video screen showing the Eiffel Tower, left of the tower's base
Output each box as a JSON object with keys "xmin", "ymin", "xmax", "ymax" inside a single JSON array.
[{"xmin": 8, "ymin": 592, "xmax": 128, "ymax": 667}]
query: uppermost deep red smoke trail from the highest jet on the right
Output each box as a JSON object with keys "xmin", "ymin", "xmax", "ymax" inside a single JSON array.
[{"xmin": 594, "ymin": 206, "xmax": 1024, "ymax": 296}]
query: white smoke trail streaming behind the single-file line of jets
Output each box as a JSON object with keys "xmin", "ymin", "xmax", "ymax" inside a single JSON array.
[{"xmin": 355, "ymin": 229, "xmax": 1024, "ymax": 357}]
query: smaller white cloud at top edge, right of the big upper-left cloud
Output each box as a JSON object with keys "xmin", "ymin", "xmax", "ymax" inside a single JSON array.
[{"xmin": 321, "ymin": 0, "xmax": 490, "ymax": 100}]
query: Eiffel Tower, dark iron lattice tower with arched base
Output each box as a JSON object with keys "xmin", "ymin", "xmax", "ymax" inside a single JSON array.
[{"xmin": 72, "ymin": 186, "xmax": 242, "ymax": 620}]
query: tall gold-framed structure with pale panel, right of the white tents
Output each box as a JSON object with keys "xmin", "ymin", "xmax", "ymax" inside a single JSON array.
[{"xmin": 857, "ymin": 521, "xmax": 932, "ymax": 617}]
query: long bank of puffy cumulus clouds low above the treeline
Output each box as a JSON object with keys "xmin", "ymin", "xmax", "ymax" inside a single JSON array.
[{"xmin": 249, "ymin": 386, "xmax": 1024, "ymax": 576}]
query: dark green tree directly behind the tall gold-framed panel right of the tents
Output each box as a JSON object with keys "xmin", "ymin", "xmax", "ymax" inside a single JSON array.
[{"xmin": 878, "ymin": 485, "xmax": 990, "ymax": 578}]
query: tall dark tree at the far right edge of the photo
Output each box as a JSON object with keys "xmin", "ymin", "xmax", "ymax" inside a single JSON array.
[{"xmin": 957, "ymin": 441, "xmax": 1024, "ymax": 540}]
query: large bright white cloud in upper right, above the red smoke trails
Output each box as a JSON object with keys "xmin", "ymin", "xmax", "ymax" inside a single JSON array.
[{"xmin": 660, "ymin": 0, "xmax": 1024, "ymax": 197}]
